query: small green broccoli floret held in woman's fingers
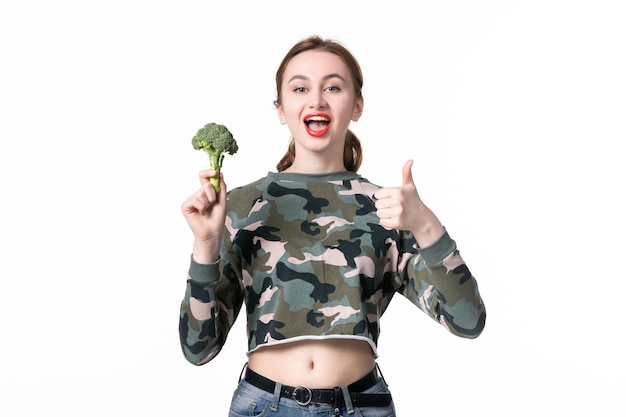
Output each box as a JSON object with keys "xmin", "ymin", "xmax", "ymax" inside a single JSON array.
[{"xmin": 191, "ymin": 123, "xmax": 239, "ymax": 193}]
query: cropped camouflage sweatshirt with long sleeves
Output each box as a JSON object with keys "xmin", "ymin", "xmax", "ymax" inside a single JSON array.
[{"xmin": 179, "ymin": 172, "xmax": 486, "ymax": 365}]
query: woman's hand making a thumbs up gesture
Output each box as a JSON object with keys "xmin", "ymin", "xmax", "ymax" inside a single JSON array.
[{"xmin": 374, "ymin": 160, "xmax": 443, "ymax": 247}]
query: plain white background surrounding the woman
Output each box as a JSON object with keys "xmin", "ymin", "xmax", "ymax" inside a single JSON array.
[{"xmin": 0, "ymin": 0, "xmax": 626, "ymax": 417}]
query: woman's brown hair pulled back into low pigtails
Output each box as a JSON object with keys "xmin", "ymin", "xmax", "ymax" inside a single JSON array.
[{"xmin": 274, "ymin": 35, "xmax": 363, "ymax": 172}]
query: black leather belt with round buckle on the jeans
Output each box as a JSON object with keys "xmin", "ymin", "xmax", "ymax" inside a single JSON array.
[{"xmin": 244, "ymin": 369, "xmax": 391, "ymax": 407}]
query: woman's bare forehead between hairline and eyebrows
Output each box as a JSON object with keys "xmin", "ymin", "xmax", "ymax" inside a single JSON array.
[{"xmin": 283, "ymin": 50, "xmax": 350, "ymax": 81}]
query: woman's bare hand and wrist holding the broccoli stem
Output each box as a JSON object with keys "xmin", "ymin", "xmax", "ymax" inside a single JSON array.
[{"xmin": 181, "ymin": 169, "xmax": 226, "ymax": 264}]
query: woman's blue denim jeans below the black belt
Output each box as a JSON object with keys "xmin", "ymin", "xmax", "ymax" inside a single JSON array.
[{"xmin": 228, "ymin": 368, "xmax": 396, "ymax": 417}]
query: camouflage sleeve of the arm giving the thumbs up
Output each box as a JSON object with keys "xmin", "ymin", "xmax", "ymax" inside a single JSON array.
[{"xmin": 398, "ymin": 231, "xmax": 486, "ymax": 339}]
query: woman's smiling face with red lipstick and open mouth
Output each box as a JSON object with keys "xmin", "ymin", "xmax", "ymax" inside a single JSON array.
[{"xmin": 278, "ymin": 50, "xmax": 363, "ymax": 165}]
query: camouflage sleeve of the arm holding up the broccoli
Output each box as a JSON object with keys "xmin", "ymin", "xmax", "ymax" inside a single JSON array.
[{"xmin": 179, "ymin": 250, "xmax": 243, "ymax": 365}]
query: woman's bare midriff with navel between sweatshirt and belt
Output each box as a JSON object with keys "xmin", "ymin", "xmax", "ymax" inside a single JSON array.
[{"xmin": 248, "ymin": 339, "xmax": 375, "ymax": 388}]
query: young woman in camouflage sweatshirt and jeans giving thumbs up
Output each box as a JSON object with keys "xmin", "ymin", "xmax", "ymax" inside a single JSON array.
[{"xmin": 180, "ymin": 36, "xmax": 486, "ymax": 417}]
